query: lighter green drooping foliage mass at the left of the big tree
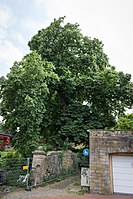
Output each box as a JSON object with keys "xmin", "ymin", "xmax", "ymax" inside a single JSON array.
[{"xmin": 1, "ymin": 52, "xmax": 57, "ymax": 155}]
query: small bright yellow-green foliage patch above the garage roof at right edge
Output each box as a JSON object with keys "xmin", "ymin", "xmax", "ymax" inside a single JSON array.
[{"xmin": 114, "ymin": 113, "xmax": 133, "ymax": 130}]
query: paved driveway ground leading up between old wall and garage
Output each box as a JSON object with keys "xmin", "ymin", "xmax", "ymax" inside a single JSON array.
[{"xmin": 2, "ymin": 177, "xmax": 133, "ymax": 199}]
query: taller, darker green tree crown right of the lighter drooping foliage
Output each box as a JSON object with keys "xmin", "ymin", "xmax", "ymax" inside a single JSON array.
[{"xmin": 29, "ymin": 18, "xmax": 133, "ymax": 147}]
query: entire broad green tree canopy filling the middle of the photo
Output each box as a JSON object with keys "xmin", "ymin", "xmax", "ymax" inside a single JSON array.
[{"xmin": 1, "ymin": 18, "xmax": 133, "ymax": 154}]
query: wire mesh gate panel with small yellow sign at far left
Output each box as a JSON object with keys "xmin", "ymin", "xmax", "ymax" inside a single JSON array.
[{"xmin": 0, "ymin": 158, "xmax": 32, "ymax": 188}]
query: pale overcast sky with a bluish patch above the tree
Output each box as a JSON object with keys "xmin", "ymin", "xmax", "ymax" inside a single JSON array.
[{"xmin": 0, "ymin": 0, "xmax": 133, "ymax": 78}]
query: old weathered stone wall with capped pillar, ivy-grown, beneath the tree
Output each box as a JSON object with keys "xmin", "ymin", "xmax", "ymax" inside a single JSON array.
[{"xmin": 32, "ymin": 150, "xmax": 78, "ymax": 186}]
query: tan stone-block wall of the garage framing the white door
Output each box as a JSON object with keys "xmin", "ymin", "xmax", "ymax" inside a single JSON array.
[{"xmin": 89, "ymin": 130, "xmax": 133, "ymax": 194}]
